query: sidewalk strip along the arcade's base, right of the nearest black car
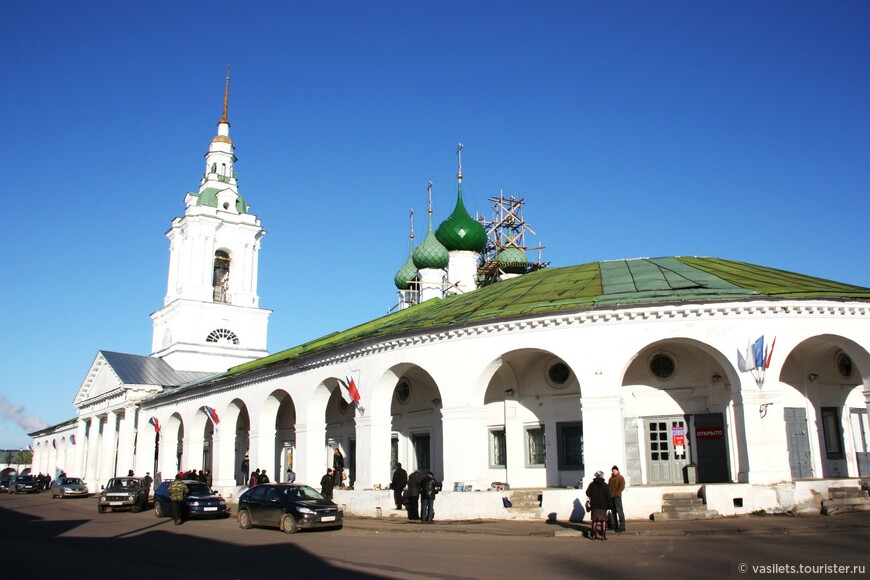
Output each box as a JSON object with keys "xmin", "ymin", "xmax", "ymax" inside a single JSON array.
[{"xmin": 344, "ymin": 512, "xmax": 870, "ymax": 538}]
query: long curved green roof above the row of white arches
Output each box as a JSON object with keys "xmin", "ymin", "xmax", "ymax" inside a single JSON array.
[{"xmin": 225, "ymin": 257, "xmax": 870, "ymax": 376}]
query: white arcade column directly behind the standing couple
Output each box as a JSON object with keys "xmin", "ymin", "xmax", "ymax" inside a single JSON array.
[{"xmin": 580, "ymin": 394, "xmax": 638, "ymax": 489}]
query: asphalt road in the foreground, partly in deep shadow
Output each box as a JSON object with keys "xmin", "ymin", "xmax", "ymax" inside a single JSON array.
[{"xmin": 0, "ymin": 493, "xmax": 870, "ymax": 580}]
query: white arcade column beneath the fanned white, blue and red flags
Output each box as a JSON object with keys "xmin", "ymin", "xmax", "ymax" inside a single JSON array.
[{"xmin": 734, "ymin": 381, "xmax": 791, "ymax": 484}]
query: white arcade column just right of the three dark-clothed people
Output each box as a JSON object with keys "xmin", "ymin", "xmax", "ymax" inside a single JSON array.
[{"xmin": 436, "ymin": 407, "xmax": 490, "ymax": 490}]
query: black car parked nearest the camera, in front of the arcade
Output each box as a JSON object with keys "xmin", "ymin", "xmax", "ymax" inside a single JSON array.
[{"xmin": 239, "ymin": 483, "xmax": 343, "ymax": 534}]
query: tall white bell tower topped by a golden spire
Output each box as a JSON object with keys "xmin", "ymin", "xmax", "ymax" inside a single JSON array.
[{"xmin": 151, "ymin": 67, "xmax": 272, "ymax": 372}]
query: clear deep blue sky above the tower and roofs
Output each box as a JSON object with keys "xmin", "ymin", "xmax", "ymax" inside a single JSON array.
[{"xmin": 0, "ymin": 0, "xmax": 870, "ymax": 448}]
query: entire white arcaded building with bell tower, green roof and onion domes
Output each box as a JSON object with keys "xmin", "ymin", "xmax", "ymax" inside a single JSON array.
[{"xmin": 32, "ymin": 78, "xmax": 870, "ymax": 519}]
